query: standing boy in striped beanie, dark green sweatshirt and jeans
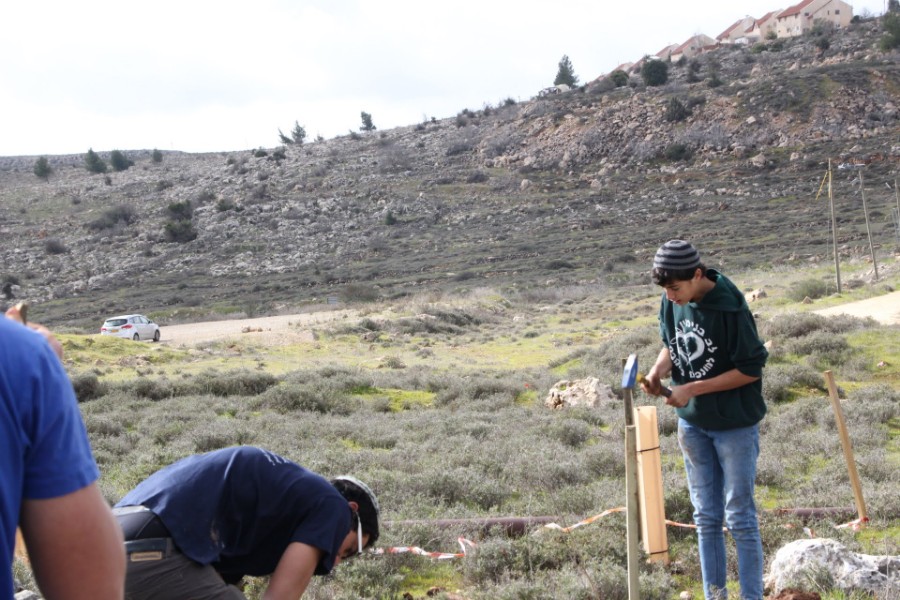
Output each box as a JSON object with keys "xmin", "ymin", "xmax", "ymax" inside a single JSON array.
[{"xmin": 641, "ymin": 240, "xmax": 768, "ymax": 600}]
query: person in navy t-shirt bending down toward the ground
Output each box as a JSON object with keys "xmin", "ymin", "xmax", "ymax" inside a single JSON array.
[{"xmin": 113, "ymin": 446, "xmax": 379, "ymax": 600}]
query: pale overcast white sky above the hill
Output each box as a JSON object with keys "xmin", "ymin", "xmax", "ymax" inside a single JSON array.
[{"xmin": 0, "ymin": 0, "xmax": 887, "ymax": 156}]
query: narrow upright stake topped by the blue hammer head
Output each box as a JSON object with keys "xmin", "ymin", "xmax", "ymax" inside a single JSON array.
[{"xmin": 622, "ymin": 354, "xmax": 641, "ymax": 600}]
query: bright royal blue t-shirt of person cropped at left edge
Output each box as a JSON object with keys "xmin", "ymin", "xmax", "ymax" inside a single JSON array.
[{"xmin": 0, "ymin": 316, "xmax": 99, "ymax": 598}]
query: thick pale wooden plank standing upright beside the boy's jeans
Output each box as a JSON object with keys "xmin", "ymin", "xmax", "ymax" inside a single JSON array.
[{"xmin": 634, "ymin": 406, "xmax": 669, "ymax": 564}]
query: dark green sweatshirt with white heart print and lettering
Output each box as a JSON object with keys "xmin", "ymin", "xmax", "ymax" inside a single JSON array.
[{"xmin": 659, "ymin": 269, "xmax": 769, "ymax": 429}]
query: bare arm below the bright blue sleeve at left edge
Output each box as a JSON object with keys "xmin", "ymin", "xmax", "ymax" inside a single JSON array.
[{"xmin": 20, "ymin": 483, "xmax": 125, "ymax": 600}]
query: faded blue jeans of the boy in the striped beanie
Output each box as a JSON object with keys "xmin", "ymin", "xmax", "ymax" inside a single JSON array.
[{"xmin": 678, "ymin": 419, "xmax": 763, "ymax": 600}]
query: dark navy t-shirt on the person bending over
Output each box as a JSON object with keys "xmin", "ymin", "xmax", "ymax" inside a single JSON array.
[{"xmin": 116, "ymin": 446, "xmax": 351, "ymax": 578}]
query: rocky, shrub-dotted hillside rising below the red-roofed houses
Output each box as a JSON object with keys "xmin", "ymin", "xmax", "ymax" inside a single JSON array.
[{"xmin": 0, "ymin": 20, "xmax": 900, "ymax": 328}]
